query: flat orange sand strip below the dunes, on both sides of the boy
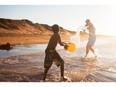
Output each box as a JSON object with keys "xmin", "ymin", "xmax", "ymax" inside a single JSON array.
[{"xmin": 0, "ymin": 33, "xmax": 71, "ymax": 45}]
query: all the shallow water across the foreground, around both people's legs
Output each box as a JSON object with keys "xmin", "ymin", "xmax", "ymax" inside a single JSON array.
[{"xmin": 0, "ymin": 38, "xmax": 116, "ymax": 82}]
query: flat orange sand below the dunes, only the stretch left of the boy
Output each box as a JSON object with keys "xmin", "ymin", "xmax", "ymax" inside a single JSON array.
[{"xmin": 0, "ymin": 35, "xmax": 51, "ymax": 45}]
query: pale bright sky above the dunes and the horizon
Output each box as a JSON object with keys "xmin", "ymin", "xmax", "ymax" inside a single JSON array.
[{"xmin": 0, "ymin": 5, "xmax": 116, "ymax": 35}]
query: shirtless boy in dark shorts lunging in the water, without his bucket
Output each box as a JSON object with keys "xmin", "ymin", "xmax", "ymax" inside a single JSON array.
[{"xmin": 43, "ymin": 24, "xmax": 66, "ymax": 81}]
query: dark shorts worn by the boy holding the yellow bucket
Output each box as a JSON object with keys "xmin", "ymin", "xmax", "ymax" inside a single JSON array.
[{"xmin": 44, "ymin": 49, "xmax": 64, "ymax": 68}]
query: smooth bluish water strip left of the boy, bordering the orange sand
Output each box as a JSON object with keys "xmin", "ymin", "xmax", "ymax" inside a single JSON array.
[{"xmin": 0, "ymin": 44, "xmax": 47, "ymax": 58}]
